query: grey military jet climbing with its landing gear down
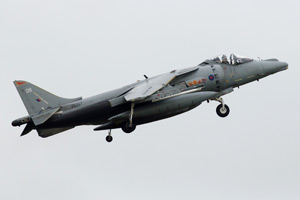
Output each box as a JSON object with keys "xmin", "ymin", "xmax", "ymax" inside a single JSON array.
[{"xmin": 12, "ymin": 54, "xmax": 288, "ymax": 142}]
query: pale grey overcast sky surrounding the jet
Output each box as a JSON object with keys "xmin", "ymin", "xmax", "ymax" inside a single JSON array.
[{"xmin": 0, "ymin": 0, "xmax": 300, "ymax": 200}]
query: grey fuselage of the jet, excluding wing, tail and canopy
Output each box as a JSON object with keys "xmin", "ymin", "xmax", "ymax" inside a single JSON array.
[{"xmin": 32, "ymin": 59, "xmax": 287, "ymax": 134}]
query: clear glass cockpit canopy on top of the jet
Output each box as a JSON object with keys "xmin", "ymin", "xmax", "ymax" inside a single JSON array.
[{"xmin": 208, "ymin": 53, "xmax": 253, "ymax": 65}]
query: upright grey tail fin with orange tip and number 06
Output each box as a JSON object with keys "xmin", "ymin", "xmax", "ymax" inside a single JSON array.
[{"xmin": 14, "ymin": 81, "xmax": 82, "ymax": 116}]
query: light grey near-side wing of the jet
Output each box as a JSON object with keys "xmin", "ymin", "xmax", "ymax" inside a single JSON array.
[{"xmin": 124, "ymin": 66, "xmax": 198, "ymax": 102}]
